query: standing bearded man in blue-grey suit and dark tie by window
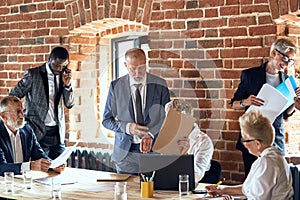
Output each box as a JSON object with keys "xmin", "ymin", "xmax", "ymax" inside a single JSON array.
[{"xmin": 102, "ymin": 48, "xmax": 170, "ymax": 174}]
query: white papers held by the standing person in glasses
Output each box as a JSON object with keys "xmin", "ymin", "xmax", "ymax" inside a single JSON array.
[{"xmin": 246, "ymin": 83, "xmax": 288, "ymax": 123}]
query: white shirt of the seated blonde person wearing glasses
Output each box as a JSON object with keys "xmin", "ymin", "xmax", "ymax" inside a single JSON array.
[{"xmin": 242, "ymin": 146, "xmax": 294, "ymax": 200}]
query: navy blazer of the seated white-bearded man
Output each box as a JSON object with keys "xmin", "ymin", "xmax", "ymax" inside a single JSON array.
[{"xmin": 0, "ymin": 120, "xmax": 51, "ymax": 176}]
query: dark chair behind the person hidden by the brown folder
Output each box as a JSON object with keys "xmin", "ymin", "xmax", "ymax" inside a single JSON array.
[{"xmin": 199, "ymin": 160, "xmax": 222, "ymax": 184}]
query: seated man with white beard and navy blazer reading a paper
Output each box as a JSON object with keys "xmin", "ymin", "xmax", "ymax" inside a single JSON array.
[{"xmin": 0, "ymin": 96, "xmax": 65, "ymax": 176}]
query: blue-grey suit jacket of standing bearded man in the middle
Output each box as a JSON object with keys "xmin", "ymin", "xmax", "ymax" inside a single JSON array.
[{"xmin": 102, "ymin": 73, "xmax": 170, "ymax": 161}]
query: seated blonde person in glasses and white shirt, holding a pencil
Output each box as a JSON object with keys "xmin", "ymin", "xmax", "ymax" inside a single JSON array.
[{"xmin": 206, "ymin": 110, "xmax": 294, "ymax": 200}]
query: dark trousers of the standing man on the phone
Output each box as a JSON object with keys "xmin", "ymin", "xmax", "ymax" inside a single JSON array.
[{"xmin": 39, "ymin": 126, "xmax": 65, "ymax": 159}]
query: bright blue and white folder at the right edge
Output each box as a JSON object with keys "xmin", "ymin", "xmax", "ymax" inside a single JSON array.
[{"xmin": 276, "ymin": 76, "xmax": 298, "ymax": 111}]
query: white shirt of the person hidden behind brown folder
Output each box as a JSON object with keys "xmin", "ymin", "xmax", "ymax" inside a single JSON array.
[{"xmin": 187, "ymin": 124, "xmax": 214, "ymax": 181}]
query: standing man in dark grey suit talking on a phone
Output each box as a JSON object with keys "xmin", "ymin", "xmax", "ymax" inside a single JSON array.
[{"xmin": 10, "ymin": 47, "xmax": 74, "ymax": 159}]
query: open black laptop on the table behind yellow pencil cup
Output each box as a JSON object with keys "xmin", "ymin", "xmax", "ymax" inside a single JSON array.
[{"xmin": 139, "ymin": 154, "xmax": 195, "ymax": 191}]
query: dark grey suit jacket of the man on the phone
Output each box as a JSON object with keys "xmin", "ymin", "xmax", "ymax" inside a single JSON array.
[{"xmin": 10, "ymin": 63, "xmax": 74, "ymax": 144}]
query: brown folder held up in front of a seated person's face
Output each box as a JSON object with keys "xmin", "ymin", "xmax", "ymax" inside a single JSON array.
[{"xmin": 152, "ymin": 109, "xmax": 195, "ymax": 155}]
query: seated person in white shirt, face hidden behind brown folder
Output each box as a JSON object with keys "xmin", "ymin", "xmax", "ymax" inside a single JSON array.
[{"xmin": 165, "ymin": 99, "xmax": 221, "ymax": 183}]
